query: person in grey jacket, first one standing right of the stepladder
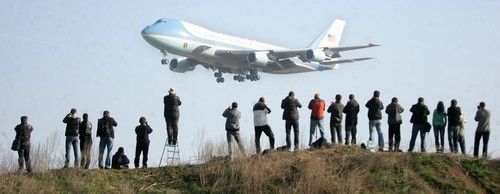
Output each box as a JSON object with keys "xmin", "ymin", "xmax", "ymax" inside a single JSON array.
[{"xmin": 222, "ymin": 102, "xmax": 246, "ymax": 156}]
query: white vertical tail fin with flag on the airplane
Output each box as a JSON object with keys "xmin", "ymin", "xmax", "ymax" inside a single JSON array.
[{"xmin": 307, "ymin": 19, "xmax": 345, "ymax": 49}]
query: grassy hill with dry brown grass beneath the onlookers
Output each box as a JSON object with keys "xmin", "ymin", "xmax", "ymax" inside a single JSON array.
[{"xmin": 0, "ymin": 146, "xmax": 500, "ymax": 193}]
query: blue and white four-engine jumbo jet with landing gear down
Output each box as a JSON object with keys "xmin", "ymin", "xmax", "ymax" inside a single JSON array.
[{"xmin": 141, "ymin": 18, "xmax": 379, "ymax": 83}]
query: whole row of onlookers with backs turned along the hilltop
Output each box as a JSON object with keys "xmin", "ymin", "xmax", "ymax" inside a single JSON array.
[{"xmin": 12, "ymin": 88, "xmax": 490, "ymax": 172}]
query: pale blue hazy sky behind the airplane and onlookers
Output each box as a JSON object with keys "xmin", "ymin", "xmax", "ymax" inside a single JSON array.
[{"xmin": 0, "ymin": 0, "xmax": 500, "ymax": 166}]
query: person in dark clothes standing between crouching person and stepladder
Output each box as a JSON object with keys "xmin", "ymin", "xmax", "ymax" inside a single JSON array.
[{"xmin": 134, "ymin": 117, "xmax": 153, "ymax": 168}]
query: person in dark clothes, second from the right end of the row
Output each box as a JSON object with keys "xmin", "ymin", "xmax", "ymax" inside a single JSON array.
[{"xmin": 448, "ymin": 99, "xmax": 462, "ymax": 153}]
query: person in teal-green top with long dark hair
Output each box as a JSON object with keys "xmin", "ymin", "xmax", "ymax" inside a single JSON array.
[{"xmin": 432, "ymin": 101, "xmax": 448, "ymax": 152}]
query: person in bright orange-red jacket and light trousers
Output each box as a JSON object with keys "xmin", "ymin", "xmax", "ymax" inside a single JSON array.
[{"xmin": 308, "ymin": 93, "xmax": 325, "ymax": 146}]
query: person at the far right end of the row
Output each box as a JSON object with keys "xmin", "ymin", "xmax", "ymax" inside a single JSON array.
[{"xmin": 474, "ymin": 102, "xmax": 490, "ymax": 158}]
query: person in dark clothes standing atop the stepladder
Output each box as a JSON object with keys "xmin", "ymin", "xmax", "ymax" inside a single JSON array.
[{"xmin": 163, "ymin": 88, "xmax": 182, "ymax": 146}]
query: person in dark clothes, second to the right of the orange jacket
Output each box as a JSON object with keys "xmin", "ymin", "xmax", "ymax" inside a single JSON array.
[{"xmin": 343, "ymin": 94, "xmax": 359, "ymax": 145}]
